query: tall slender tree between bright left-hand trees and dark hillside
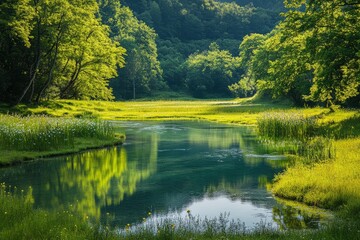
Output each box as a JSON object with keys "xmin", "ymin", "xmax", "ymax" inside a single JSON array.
[{"xmin": 100, "ymin": 1, "xmax": 166, "ymax": 99}]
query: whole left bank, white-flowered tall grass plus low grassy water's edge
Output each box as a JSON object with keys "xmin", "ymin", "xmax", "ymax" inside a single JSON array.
[{"xmin": 0, "ymin": 114, "xmax": 124, "ymax": 165}]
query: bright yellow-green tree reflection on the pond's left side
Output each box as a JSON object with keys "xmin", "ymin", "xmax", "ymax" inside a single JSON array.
[{"xmin": 59, "ymin": 135, "xmax": 157, "ymax": 218}]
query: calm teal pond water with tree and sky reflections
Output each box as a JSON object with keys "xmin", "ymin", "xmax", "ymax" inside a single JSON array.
[{"xmin": 0, "ymin": 122, "xmax": 321, "ymax": 228}]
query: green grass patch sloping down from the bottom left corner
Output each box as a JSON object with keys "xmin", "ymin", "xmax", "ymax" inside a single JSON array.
[{"xmin": 0, "ymin": 183, "xmax": 115, "ymax": 240}]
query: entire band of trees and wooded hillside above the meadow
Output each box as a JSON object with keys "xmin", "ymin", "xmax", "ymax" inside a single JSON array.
[{"xmin": 0, "ymin": 0, "xmax": 360, "ymax": 106}]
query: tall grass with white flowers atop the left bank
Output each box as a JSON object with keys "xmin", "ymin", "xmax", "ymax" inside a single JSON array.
[{"xmin": 0, "ymin": 114, "xmax": 114, "ymax": 151}]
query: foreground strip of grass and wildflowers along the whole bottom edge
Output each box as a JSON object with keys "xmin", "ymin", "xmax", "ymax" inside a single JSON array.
[{"xmin": 0, "ymin": 184, "xmax": 360, "ymax": 240}]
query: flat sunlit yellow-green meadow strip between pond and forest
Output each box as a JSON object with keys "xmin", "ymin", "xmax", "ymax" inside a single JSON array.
[{"xmin": 11, "ymin": 98, "xmax": 359, "ymax": 125}]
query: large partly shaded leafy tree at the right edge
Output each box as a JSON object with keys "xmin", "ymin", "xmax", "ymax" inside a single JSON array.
[{"xmin": 283, "ymin": 0, "xmax": 360, "ymax": 105}]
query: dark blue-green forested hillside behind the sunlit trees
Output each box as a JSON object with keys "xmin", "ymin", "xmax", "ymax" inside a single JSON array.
[{"xmin": 122, "ymin": 0, "xmax": 282, "ymax": 97}]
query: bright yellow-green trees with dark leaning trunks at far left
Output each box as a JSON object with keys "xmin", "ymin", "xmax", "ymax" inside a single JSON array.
[{"xmin": 0, "ymin": 0, "xmax": 124, "ymax": 103}]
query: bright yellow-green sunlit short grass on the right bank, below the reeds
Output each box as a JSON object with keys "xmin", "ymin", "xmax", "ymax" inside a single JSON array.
[{"xmin": 272, "ymin": 138, "xmax": 360, "ymax": 209}]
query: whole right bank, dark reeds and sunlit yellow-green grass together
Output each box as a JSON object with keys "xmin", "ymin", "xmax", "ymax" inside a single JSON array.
[{"xmin": 258, "ymin": 109, "xmax": 360, "ymax": 215}]
